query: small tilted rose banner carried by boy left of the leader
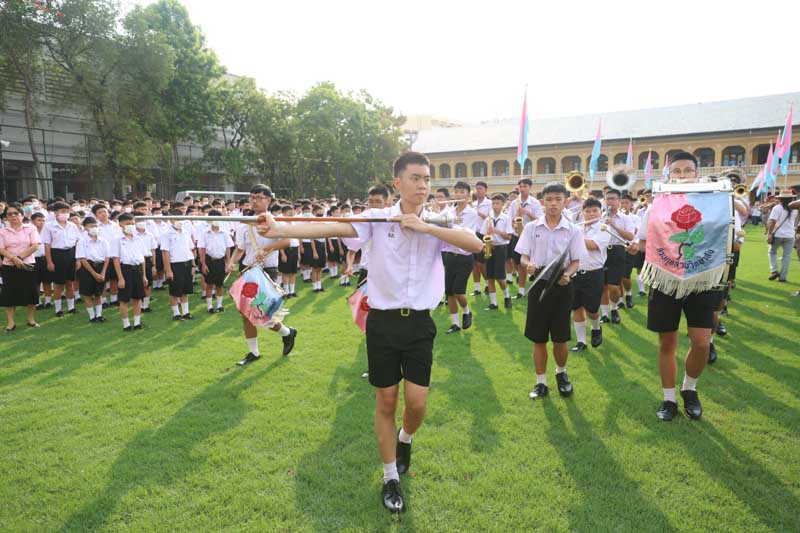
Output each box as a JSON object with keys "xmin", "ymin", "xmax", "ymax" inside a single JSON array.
[{"xmin": 228, "ymin": 267, "xmax": 288, "ymax": 327}]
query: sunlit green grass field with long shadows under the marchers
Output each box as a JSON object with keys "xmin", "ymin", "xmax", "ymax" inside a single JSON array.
[{"xmin": 0, "ymin": 235, "xmax": 800, "ymax": 531}]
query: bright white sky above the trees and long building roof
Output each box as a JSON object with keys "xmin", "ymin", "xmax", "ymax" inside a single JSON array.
[{"xmin": 128, "ymin": 0, "xmax": 800, "ymax": 122}]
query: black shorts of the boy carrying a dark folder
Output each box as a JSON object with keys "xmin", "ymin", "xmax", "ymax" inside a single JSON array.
[{"xmin": 525, "ymin": 281, "xmax": 572, "ymax": 343}]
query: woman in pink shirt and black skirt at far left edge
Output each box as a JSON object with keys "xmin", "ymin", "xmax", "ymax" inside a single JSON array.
[{"xmin": 0, "ymin": 204, "xmax": 41, "ymax": 333}]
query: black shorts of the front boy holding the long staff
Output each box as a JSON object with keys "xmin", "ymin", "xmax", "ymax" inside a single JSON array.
[{"xmin": 367, "ymin": 309, "xmax": 436, "ymax": 388}]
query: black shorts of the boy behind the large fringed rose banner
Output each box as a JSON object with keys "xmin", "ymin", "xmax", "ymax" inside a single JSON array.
[{"xmin": 647, "ymin": 289, "xmax": 722, "ymax": 333}]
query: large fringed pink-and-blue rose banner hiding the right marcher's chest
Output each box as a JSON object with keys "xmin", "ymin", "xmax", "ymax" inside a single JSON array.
[{"xmin": 642, "ymin": 192, "xmax": 733, "ymax": 298}]
